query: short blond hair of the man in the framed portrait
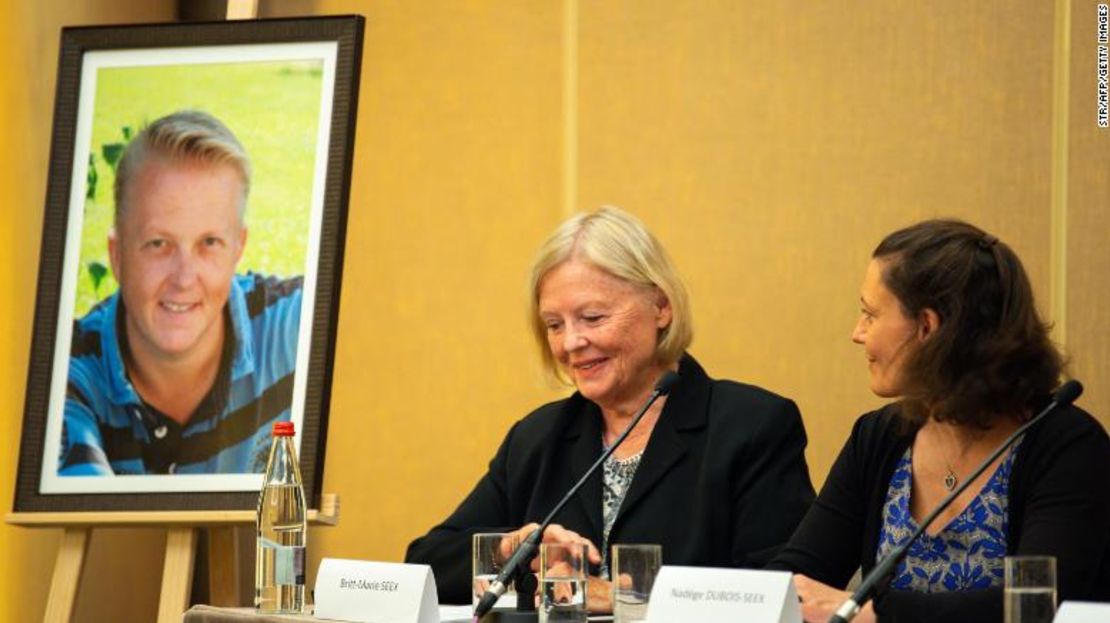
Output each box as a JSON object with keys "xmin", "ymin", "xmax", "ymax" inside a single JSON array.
[{"xmin": 114, "ymin": 110, "xmax": 251, "ymax": 225}]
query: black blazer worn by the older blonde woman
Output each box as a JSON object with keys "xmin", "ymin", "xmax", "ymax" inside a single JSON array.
[{"xmin": 405, "ymin": 356, "xmax": 814, "ymax": 603}]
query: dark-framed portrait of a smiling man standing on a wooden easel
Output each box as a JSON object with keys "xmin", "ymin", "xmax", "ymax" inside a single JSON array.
[{"xmin": 14, "ymin": 17, "xmax": 363, "ymax": 512}]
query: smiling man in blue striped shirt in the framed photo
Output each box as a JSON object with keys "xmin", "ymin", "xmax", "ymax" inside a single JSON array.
[{"xmin": 58, "ymin": 111, "xmax": 302, "ymax": 475}]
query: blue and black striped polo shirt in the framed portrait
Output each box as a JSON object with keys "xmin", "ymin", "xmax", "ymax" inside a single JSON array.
[{"xmin": 58, "ymin": 273, "xmax": 303, "ymax": 475}]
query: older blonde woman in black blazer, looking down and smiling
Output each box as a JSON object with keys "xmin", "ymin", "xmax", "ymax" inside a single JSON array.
[{"xmin": 405, "ymin": 208, "xmax": 814, "ymax": 611}]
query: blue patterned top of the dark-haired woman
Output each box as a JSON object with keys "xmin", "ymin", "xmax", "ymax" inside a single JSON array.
[{"xmin": 877, "ymin": 443, "xmax": 1020, "ymax": 593}]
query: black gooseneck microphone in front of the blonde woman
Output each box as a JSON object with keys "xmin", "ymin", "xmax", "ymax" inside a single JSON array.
[{"xmin": 474, "ymin": 371, "xmax": 679, "ymax": 621}]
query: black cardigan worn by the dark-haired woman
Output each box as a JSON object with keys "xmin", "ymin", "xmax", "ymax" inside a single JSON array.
[{"xmin": 769, "ymin": 404, "xmax": 1110, "ymax": 623}]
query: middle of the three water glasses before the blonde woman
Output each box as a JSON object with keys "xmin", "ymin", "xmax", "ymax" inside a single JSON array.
[{"xmin": 539, "ymin": 543, "xmax": 587, "ymax": 623}]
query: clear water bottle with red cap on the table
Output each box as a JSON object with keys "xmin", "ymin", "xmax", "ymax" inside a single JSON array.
[{"xmin": 254, "ymin": 422, "xmax": 307, "ymax": 614}]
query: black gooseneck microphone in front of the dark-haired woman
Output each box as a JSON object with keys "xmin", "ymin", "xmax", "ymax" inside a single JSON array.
[{"xmin": 828, "ymin": 379, "xmax": 1083, "ymax": 623}]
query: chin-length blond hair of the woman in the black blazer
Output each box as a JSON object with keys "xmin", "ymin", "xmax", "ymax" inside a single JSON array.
[{"xmin": 529, "ymin": 205, "xmax": 694, "ymax": 382}]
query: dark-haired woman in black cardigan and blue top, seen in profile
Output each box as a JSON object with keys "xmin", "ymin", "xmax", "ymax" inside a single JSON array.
[{"xmin": 770, "ymin": 220, "xmax": 1110, "ymax": 623}]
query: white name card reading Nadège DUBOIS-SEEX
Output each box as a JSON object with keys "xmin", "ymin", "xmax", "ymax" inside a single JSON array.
[{"xmin": 647, "ymin": 566, "xmax": 801, "ymax": 623}]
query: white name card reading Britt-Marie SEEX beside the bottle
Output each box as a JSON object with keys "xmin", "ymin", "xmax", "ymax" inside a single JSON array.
[{"xmin": 314, "ymin": 559, "xmax": 440, "ymax": 623}]
